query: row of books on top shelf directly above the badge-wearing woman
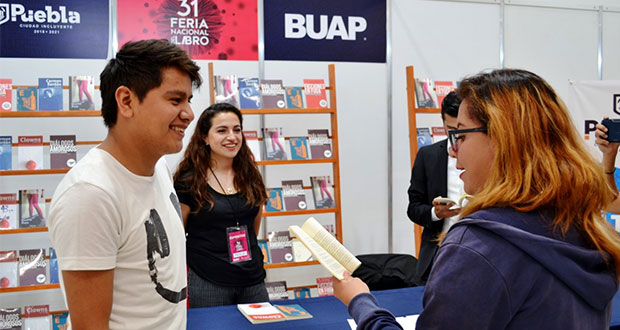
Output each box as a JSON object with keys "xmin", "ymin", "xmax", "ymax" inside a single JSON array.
[{"xmin": 213, "ymin": 75, "xmax": 327, "ymax": 109}]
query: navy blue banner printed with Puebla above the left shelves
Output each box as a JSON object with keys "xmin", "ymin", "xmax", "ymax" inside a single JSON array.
[{"xmin": 0, "ymin": 0, "xmax": 110, "ymax": 59}]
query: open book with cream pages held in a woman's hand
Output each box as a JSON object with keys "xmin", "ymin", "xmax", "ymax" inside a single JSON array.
[{"xmin": 288, "ymin": 217, "xmax": 362, "ymax": 280}]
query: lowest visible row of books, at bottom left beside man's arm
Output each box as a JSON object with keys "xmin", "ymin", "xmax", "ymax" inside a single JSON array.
[{"xmin": 0, "ymin": 305, "xmax": 69, "ymax": 330}]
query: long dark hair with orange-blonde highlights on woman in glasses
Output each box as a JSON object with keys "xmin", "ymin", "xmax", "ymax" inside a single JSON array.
[{"xmin": 458, "ymin": 69, "xmax": 620, "ymax": 276}]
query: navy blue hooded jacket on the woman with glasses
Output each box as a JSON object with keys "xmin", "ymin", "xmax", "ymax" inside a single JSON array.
[{"xmin": 349, "ymin": 208, "xmax": 618, "ymax": 330}]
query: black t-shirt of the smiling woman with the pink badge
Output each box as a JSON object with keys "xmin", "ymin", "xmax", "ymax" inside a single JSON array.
[{"xmin": 175, "ymin": 182, "xmax": 265, "ymax": 286}]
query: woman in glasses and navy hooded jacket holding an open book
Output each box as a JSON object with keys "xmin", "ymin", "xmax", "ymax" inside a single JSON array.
[{"xmin": 334, "ymin": 70, "xmax": 620, "ymax": 330}]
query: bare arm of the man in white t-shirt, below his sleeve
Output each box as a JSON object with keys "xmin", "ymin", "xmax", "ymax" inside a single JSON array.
[{"xmin": 62, "ymin": 269, "xmax": 114, "ymax": 330}]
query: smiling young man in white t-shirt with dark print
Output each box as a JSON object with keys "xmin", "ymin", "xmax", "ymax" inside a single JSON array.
[{"xmin": 49, "ymin": 40, "xmax": 202, "ymax": 329}]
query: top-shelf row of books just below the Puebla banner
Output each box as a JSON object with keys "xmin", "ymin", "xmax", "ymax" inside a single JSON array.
[{"xmin": 0, "ymin": 76, "xmax": 95, "ymax": 111}]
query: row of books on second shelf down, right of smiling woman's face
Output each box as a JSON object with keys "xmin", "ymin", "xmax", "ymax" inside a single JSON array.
[{"xmin": 243, "ymin": 127, "xmax": 332, "ymax": 161}]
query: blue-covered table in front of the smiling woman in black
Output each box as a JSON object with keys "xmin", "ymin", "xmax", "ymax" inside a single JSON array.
[{"xmin": 187, "ymin": 287, "xmax": 620, "ymax": 330}]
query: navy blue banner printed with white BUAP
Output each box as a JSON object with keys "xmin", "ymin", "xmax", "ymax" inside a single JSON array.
[{"xmin": 264, "ymin": 0, "xmax": 386, "ymax": 63}]
